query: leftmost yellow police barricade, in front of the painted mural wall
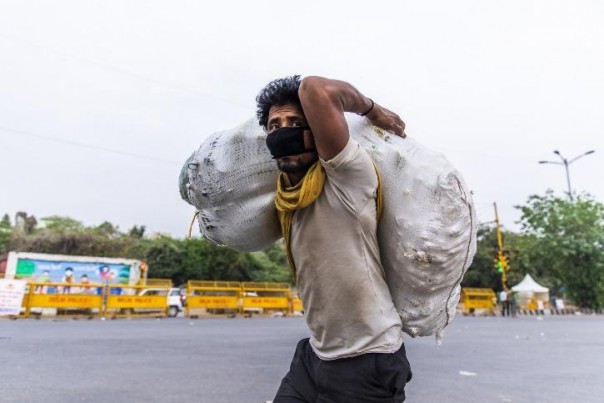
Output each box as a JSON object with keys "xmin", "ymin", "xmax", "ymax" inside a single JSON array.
[{"xmin": 23, "ymin": 282, "xmax": 103, "ymax": 317}]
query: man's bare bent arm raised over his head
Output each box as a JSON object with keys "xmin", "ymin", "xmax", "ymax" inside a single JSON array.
[{"xmin": 298, "ymin": 77, "xmax": 405, "ymax": 160}]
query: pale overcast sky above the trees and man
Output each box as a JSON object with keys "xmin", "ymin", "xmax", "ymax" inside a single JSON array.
[{"xmin": 0, "ymin": 0, "xmax": 604, "ymax": 237}]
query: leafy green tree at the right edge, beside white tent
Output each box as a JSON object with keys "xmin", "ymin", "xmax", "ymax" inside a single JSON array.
[{"xmin": 518, "ymin": 191, "xmax": 604, "ymax": 309}]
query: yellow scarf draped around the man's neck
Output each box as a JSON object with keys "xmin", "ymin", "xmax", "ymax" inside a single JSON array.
[{"xmin": 275, "ymin": 161, "xmax": 383, "ymax": 279}]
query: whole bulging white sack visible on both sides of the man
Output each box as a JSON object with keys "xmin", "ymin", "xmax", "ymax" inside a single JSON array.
[{"xmin": 180, "ymin": 114, "xmax": 476, "ymax": 337}]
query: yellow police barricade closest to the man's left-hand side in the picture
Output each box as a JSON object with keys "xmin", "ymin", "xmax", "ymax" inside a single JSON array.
[{"xmin": 241, "ymin": 282, "xmax": 292, "ymax": 316}]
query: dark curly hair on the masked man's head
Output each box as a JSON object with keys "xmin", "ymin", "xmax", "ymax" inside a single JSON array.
[{"xmin": 256, "ymin": 75, "xmax": 301, "ymax": 127}]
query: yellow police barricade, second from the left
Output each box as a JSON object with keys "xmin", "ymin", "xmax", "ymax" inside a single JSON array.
[{"xmin": 104, "ymin": 280, "xmax": 172, "ymax": 317}]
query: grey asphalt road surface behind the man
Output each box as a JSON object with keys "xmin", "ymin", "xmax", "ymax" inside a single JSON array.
[{"xmin": 0, "ymin": 316, "xmax": 604, "ymax": 403}]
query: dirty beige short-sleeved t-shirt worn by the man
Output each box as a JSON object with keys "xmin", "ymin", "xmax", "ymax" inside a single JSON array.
[{"xmin": 291, "ymin": 138, "xmax": 403, "ymax": 360}]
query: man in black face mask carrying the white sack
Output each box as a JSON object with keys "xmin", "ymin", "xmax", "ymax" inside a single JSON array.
[{"xmin": 256, "ymin": 76, "xmax": 411, "ymax": 403}]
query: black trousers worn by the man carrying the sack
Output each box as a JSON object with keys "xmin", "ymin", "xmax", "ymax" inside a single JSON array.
[{"xmin": 273, "ymin": 339, "xmax": 411, "ymax": 403}]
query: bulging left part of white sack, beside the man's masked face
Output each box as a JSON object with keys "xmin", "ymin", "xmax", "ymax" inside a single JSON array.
[{"xmin": 180, "ymin": 118, "xmax": 281, "ymax": 252}]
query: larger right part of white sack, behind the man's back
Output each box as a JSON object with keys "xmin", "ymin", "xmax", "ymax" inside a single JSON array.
[{"xmin": 348, "ymin": 116, "xmax": 477, "ymax": 337}]
